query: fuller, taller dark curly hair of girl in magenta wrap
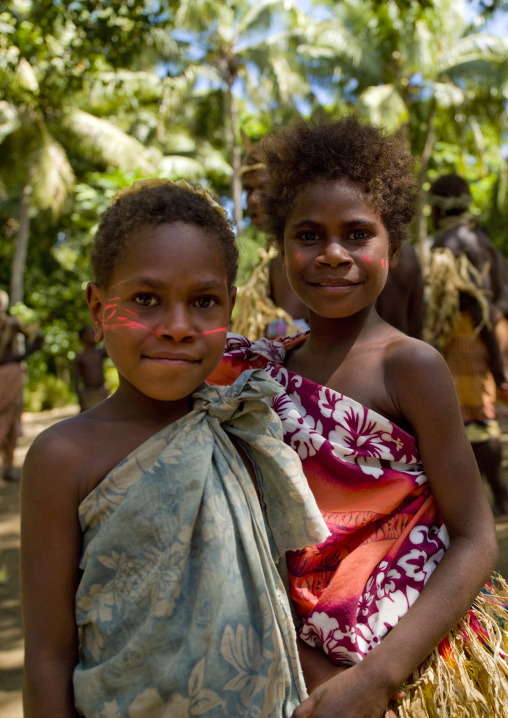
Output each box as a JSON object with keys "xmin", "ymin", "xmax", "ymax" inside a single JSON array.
[{"xmin": 261, "ymin": 114, "xmax": 417, "ymax": 251}]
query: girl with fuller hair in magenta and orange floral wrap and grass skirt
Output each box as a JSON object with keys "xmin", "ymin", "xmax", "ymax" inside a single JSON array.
[{"xmin": 209, "ymin": 117, "xmax": 508, "ymax": 718}]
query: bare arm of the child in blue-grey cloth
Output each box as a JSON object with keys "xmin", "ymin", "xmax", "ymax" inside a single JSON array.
[{"xmin": 21, "ymin": 429, "xmax": 81, "ymax": 718}]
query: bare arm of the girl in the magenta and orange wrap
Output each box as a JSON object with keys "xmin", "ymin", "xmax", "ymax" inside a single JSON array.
[{"xmin": 294, "ymin": 343, "xmax": 497, "ymax": 718}]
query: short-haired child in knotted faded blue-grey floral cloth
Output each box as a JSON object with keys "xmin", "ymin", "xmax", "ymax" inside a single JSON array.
[{"xmin": 22, "ymin": 180, "xmax": 328, "ymax": 718}]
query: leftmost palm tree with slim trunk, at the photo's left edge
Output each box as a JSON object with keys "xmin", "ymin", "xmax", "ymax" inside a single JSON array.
[{"xmin": 0, "ymin": 13, "xmax": 156, "ymax": 304}]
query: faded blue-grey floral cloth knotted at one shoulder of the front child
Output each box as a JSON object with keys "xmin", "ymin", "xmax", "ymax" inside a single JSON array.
[{"xmin": 74, "ymin": 371, "xmax": 329, "ymax": 718}]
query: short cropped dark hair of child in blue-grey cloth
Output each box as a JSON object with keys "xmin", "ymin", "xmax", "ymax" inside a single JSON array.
[{"xmin": 91, "ymin": 184, "xmax": 238, "ymax": 287}]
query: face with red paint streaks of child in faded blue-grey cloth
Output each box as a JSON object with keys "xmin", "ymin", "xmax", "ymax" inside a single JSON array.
[{"xmin": 87, "ymin": 222, "xmax": 234, "ymax": 401}]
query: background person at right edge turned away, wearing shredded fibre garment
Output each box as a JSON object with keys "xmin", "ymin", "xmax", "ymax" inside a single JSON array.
[{"xmin": 426, "ymin": 174, "xmax": 508, "ymax": 516}]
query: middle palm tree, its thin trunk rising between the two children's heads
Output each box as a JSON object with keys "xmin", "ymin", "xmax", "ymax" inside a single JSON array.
[{"xmin": 168, "ymin": 0, "xmax": 308, "ymax": 230}]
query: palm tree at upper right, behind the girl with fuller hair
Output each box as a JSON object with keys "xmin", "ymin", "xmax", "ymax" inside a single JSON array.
[{"xmin": 302, "ymin": 0, "xmax": 508, "ymax": 258}]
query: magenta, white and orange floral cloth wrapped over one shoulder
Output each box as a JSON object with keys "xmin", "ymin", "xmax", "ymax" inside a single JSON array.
[{"xmin": 209, "ymin": 334, "xmax": 449, "ymax": 665}]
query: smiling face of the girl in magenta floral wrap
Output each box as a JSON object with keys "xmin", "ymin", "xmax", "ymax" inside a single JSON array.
[{"xmin": 284, "ymin": 180, "xmax": 390, "ymax": 318}]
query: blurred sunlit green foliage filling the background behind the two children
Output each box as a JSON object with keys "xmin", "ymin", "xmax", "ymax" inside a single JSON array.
[{"xmin": 0, "ymin": 0, "xmax": 508, "ymax": 408}]
